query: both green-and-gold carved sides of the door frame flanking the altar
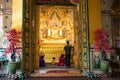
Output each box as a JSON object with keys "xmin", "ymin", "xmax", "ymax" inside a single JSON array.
[{"xmin": 22, "ymin": 0, "xmax": 89, "ymax": 73}]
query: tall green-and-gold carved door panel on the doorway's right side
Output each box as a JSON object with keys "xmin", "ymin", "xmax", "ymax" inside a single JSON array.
[{"xmin": 79, "ymin": 0, "xmax": 89, "ymax": 71}]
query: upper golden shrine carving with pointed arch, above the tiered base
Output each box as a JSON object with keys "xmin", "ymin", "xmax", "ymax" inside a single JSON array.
[{"xmin": 39, "ymin": 6, "xmax": 74, "ymax": 43}]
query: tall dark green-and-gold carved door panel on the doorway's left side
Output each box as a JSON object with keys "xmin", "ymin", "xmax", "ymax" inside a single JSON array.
[{"xmin": 22, "ymin": 0, "xmax": 32, "ymax": 73}]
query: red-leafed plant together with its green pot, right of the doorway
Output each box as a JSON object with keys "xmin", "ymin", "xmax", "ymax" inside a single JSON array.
[{"xmin": 94, "ymin": 29, "xmax": 112, "ymax": 72}]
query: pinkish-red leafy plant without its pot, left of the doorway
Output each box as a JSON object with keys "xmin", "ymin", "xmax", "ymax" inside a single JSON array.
[{"xmin": 5, "ymin": 29, "xmax": 22, "ymax": 62}]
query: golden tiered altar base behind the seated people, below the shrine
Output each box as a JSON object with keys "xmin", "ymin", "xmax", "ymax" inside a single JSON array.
[{"xmin": 40, "ymin": 43, "xmax": 65, "ymax": 62}]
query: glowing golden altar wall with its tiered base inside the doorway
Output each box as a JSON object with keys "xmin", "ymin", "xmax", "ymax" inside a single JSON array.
[{"xmin": 38, "ymin": 6, "xmax": 74, "ymax": 63}]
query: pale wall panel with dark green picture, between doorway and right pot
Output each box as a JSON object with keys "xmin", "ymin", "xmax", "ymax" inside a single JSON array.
[{"xmin": 90, "ymin": 49, "xmax": 101, "ymax": 71}]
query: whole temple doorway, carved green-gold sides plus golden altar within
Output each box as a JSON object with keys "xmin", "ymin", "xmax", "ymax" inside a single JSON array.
[{"xmin": 22, "ymin": 0, "xmax": 89, "ymax": 72}]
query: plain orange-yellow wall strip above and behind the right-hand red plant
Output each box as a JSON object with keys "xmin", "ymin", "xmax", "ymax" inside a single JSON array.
[{"xmin": 88, "ymin": 0, "xmax": 102, "ymax": 47}]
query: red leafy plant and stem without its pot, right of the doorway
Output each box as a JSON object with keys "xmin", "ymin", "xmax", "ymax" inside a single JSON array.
[{"xmin": 94, "ymin": 29, "xmax": 112, "ymax": 60}]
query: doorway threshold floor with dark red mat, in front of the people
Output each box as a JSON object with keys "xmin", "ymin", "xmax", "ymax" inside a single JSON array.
[{"xmin": 30, "ymin": 69, "xmax": 81, "ymax": 77}]
